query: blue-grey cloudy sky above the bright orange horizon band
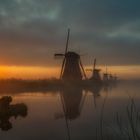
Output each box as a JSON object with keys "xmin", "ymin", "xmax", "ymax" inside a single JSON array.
[{"xmin": 0, "ymin": 0, "xmax": 140, "ymax": 66}]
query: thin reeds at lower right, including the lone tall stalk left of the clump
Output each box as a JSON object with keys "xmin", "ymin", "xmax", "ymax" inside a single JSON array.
[{"xmin": 96, "ymin": 97, "xmax": 140, "ymax": 140}]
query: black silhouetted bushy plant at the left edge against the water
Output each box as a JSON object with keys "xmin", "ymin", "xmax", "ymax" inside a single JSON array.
[{"xmin": 0, "ymin": 96, "xmax": 28, "ymax": 131}]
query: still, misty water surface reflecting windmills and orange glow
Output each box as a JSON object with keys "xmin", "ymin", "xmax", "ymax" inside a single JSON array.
[{"xmin": 0, "ymin": 82, "xmax": 140, "ymax": 140}]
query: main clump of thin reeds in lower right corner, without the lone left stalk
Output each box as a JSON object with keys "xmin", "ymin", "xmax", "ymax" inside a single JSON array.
[{"xmin": 107, "ymin": 98, "xmax": 140, "ymax": 140}]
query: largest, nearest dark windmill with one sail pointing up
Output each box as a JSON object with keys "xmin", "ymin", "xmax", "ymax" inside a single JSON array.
[{"xmin": 54, "ymin": 29, "xmax": 86, "ymax": 82}]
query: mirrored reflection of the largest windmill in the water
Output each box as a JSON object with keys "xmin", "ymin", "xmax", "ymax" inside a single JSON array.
[{"xmin": 56, "ymin": 87, "xmax": 85, "ymax": 140}]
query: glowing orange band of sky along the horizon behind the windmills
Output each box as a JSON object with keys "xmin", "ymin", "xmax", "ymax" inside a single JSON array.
[{"xmin": 0, "ymin": 65, "xmax": 140, "ymax": 79}]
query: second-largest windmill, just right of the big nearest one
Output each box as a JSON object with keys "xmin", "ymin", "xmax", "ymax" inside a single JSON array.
[{"xmin": 87, "ymin": 58, "xmax": 101, "ymax": 82}]
